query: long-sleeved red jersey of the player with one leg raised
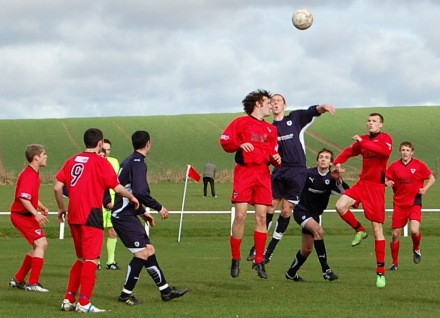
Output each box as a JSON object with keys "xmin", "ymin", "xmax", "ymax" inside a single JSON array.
[{"xmin": 334, "ymin": 132, "xmax": 393, "ymax": 183}]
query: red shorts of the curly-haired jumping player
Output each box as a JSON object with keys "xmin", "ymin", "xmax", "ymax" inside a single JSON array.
[{"xmin": 231, "ymin": 164, "xmax": 272, "ymax": 205}]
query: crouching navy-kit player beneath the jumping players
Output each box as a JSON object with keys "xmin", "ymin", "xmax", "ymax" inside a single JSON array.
[{"xmin": 285, "ymin": 148, "xmax": 348, "ymax": 282}]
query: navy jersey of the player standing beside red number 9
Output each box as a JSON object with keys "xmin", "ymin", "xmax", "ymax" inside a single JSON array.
[{"xmin": 112, "ymin": 151, "xmax": 162, "ymax": 217}]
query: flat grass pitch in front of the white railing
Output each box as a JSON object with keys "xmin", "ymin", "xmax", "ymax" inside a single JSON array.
[{"xmin": 0, "ymin": 213, "xmax": 440, "ymax": 318}]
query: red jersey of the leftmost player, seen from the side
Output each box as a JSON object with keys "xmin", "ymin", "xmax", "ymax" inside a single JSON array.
[{"xmin": 11, "ymin": 166, "xmax": 41, "ymax": 214}]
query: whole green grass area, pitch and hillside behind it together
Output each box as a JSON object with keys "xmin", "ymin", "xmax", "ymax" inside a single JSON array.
[{"xmin": 0, "ymin": 107, "xmax": 440, "ymax": 318}]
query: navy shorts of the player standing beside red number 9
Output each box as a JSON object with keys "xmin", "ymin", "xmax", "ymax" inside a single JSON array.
[{"xmin": 112, "ymin": 213, "xmax": 151, "ymax": 249}]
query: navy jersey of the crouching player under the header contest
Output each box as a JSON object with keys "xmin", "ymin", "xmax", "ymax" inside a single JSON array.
[{"xmin": 294, "ymin": 167, "xmax": 349, "ymax": 215}]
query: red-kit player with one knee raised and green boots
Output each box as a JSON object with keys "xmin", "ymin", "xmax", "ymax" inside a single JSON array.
[{"xmin": 334, "ymin": 113, "xmax": 393, "ymax": 287}]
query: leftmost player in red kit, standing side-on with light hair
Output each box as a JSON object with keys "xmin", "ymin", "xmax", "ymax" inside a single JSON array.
[{"xmin": 9, "ymin": 144, "xmax": 49, "ymax": 292}]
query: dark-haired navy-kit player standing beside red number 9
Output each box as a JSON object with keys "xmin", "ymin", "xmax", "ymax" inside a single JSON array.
[{"xmin": 112, "ymin": 131, "xmax": 188, "ymax": 306}]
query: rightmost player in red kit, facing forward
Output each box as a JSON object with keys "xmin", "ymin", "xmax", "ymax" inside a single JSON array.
[{"xmin": 385, "ymin": 141, "xmax": 435, "ymax": 270}]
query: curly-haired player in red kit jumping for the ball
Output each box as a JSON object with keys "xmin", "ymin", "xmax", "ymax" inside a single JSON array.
[{"xmin": 220, "ymin": 90, "xmax": 281, "ymax": 278}]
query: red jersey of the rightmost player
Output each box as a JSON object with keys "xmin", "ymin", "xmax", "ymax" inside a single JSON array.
[{"xmin": 386, "ymin": 158, "xmax": 432, "ymax": 206}]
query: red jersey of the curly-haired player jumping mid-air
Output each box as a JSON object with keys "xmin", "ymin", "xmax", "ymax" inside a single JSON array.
[{"xmin": 220, "ymin": 116, "xmax": 278, "ymax": 166}]
